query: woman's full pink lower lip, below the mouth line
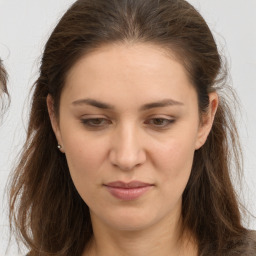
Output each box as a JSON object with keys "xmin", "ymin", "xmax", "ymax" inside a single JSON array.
[{"xmin": 106, "ymin": 186, "xmax": 152, "ymax": 201}]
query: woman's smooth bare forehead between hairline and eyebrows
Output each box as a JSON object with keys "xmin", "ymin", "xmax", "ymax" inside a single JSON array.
[{"xmin": 63, "ymin": 44, "xmax": 195, "ymax": 108}]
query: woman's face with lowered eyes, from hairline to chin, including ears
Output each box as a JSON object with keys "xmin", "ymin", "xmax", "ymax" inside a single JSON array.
[{"xmin": 48, "ymin": 44, "xmax": 217, "ymax": 230}]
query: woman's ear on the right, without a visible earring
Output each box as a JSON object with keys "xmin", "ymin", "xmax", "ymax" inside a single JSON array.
[{"xmin": 195, "ymin": 92, "xmax": 219, "ymax": 149}]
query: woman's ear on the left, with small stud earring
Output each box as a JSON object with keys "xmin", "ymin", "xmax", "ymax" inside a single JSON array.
[{"xmin": 46, "ymin": 94, "xmax": 65, "ymax": 153}]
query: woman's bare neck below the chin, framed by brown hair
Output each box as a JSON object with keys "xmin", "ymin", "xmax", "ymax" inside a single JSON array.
[{"xmin": 82, "ymin": 209, "xmax": 197, "ymax": 256}]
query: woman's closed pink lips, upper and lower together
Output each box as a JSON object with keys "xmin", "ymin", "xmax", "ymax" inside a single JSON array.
[{"xmin": 105, "ymin": 181, "xmax": 153, "ymax": 201}]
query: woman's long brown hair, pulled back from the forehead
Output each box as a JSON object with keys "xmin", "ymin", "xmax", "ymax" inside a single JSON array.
[{"xmin": 10, "ymin": 0, "xmax": 252, "ymax": 256}]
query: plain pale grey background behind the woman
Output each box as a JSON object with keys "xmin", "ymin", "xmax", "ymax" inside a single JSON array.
[{"xmin": 0, "ymin": 0, "xmax": 256, "ymax": 256}]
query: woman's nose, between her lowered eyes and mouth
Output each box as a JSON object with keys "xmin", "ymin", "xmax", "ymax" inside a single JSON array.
[{"xmin": 109, "ymin": 125, "xmax": 146, "ymax": 171}]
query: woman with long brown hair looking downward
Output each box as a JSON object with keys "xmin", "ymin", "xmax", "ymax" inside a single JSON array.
[{"xmin": 10, "ymin": 0, "xmax": 256, "ymax": 256}]
